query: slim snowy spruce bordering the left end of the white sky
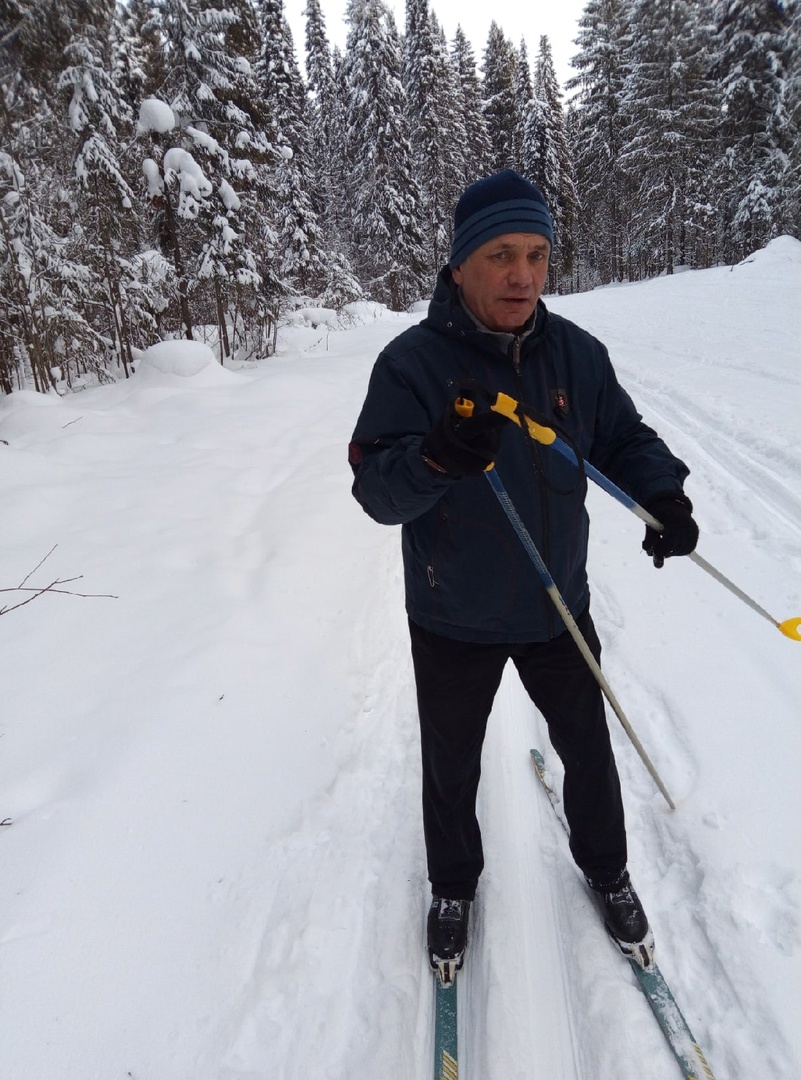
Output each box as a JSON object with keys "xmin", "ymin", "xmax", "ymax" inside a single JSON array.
[{"xmin": 256, "ymin": 0, "xmax": 326, "ymax": 296}]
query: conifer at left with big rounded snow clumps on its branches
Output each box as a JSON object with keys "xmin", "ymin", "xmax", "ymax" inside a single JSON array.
[{"xmin": 139, "ymin": 0, "xmax": 272, "ymax": 347}]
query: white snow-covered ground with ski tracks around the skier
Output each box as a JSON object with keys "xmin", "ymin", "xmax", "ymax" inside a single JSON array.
[{"xmin": 0, "ymin": 238, "xmax": 801, "ymax": 1080}]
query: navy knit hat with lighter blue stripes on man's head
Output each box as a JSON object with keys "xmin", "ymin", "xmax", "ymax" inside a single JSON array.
[{"xmin": 450, "ymin": 168, "xmax": 554, "ymax": 267}]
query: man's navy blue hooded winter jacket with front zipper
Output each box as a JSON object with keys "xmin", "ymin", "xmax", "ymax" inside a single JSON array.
[{"xmin": 350, "ymin": 268, "xmax": 689, "ymax": 643}]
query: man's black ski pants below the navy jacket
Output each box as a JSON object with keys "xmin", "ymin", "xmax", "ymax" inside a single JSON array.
[{"xmin": 409, "ymin": 609, "xmax": 626, "ymax": 900}]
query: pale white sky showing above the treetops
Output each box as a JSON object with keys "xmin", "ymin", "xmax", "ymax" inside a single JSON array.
[{"xmin": 284, "ymin": 0, "xmax": 585, "ymax": 86}]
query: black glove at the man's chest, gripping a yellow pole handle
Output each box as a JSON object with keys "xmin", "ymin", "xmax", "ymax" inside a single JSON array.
[{"xmin": 420, "ymin": 402, "xmax": 508, "ymax": 480}]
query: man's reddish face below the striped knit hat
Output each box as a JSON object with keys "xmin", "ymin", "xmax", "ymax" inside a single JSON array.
[{"xmin": 453, "ymin": 232, "xmax": 551, "ymax": 333}]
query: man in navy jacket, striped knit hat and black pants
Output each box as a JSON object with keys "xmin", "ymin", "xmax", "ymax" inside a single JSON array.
[{"xmin": 350, "ymin": 170, "xmax": 698, "ymax": 968}]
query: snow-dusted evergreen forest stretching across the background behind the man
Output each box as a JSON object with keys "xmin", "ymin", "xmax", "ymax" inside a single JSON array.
[{"xmin": 0, "ymin": 0, "xmax": 801, "ymax": 394}]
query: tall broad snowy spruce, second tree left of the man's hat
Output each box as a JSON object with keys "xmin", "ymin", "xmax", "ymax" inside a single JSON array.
[{"xmin": 342, "ymin": 0, "xmax": 433, "ymax": 311}]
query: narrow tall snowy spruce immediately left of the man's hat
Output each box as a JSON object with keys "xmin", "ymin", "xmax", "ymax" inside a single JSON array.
[{"xmin": 404, "ymin": 0, "xmax": 465, "ymax": 272}]
